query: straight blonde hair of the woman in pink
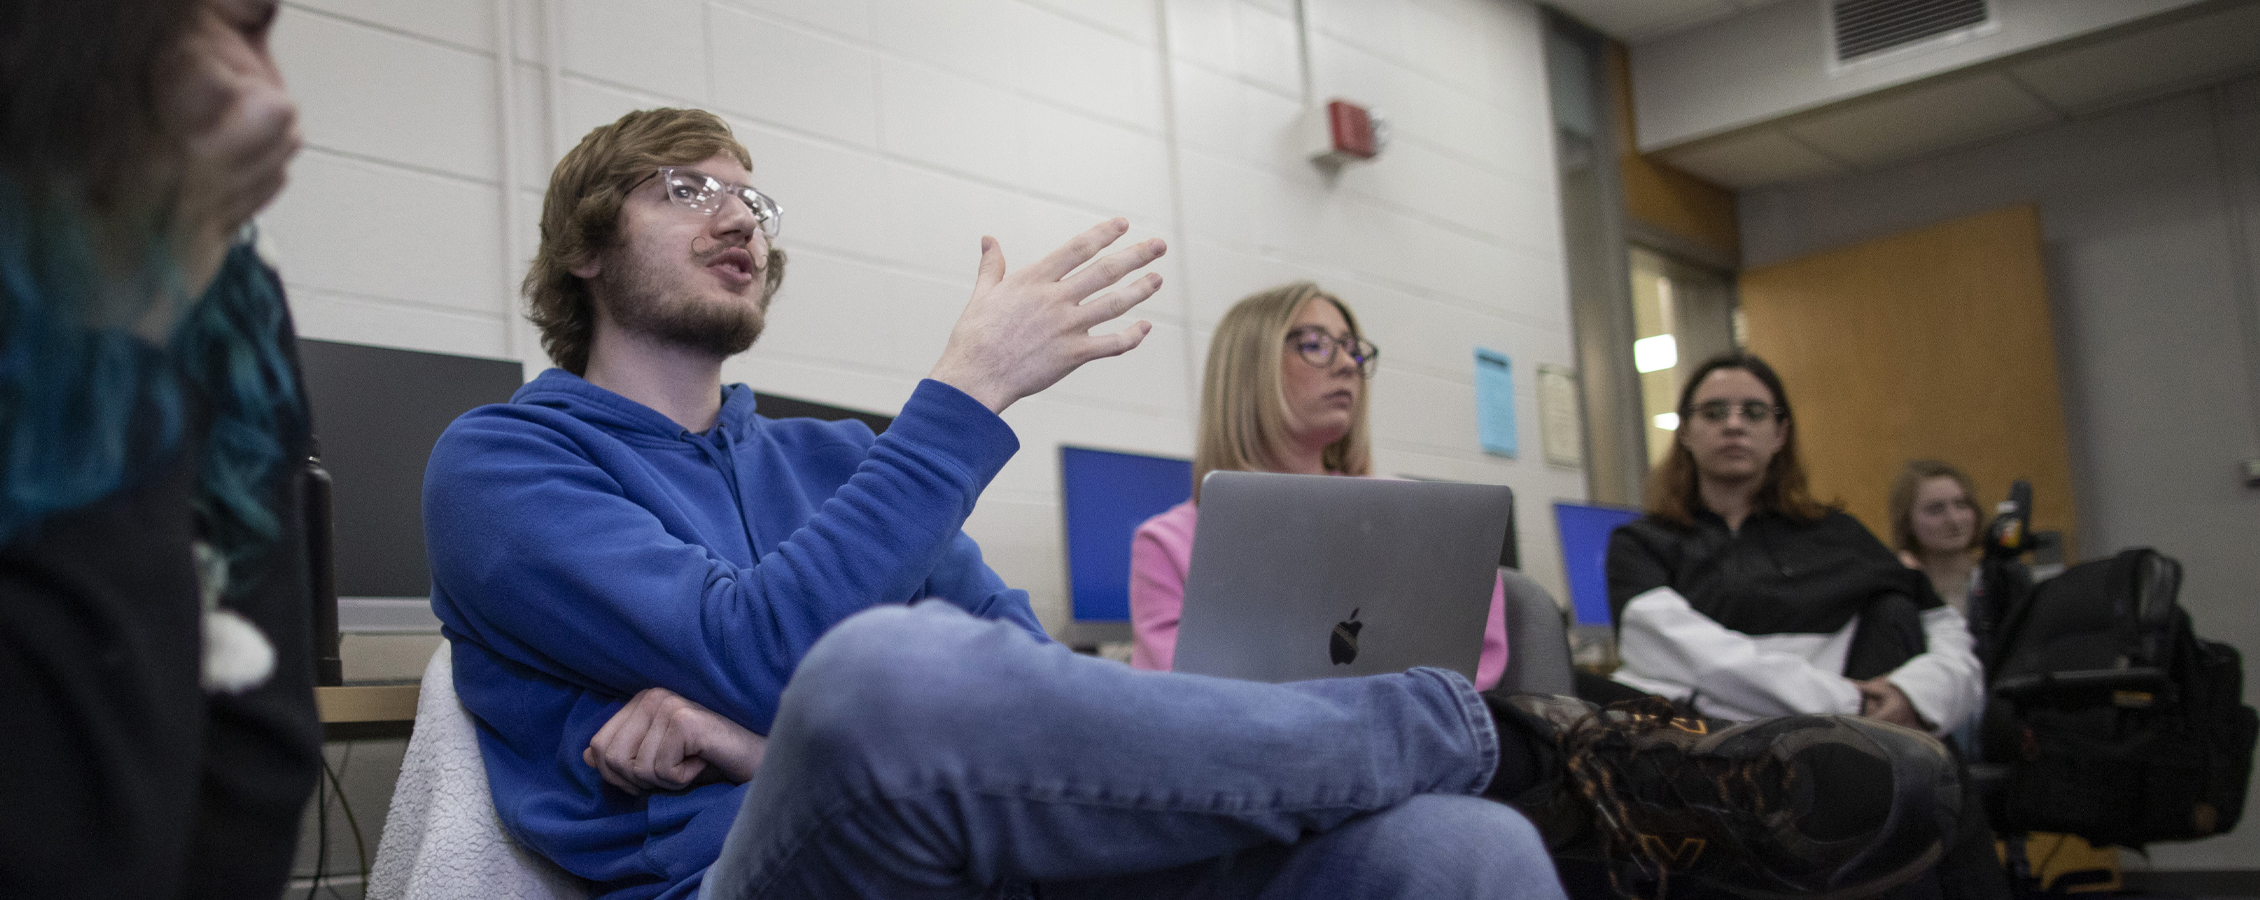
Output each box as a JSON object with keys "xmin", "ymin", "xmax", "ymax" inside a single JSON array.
[{"xmin": 1193, "ymin": 280, "xmax": 1374, "ymax": 504}]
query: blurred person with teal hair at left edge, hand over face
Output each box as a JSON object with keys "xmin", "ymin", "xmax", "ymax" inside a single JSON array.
[{"xmin": 0, "ymin": 0, "xmax": 321, "ymax": 898}]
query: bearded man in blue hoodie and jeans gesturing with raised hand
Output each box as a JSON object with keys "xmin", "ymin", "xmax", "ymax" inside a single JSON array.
[{"xmin": 425, "ymin": 109, "xmax": 1961, "ymax": 900}]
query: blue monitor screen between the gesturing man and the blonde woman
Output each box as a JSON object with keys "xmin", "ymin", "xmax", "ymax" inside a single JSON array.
[{"xmin": 1060, "ymin": 448, "xmax": 1193, "ymax": 622}]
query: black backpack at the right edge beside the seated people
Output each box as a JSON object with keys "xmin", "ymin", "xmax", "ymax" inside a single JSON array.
[{"xmin": 1980, "ymin": 549, "xmax": 2260, "ymax": 848}]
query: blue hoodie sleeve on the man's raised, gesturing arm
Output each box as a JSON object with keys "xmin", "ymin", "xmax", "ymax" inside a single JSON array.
[{"xmin": 425, "ymin": 380, "xmax": 1017, "ymax": 733}]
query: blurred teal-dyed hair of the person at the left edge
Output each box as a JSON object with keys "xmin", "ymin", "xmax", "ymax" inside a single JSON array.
[{"xmin": 0, "ymin": 179, "xmax": 305, "ymax": 588}]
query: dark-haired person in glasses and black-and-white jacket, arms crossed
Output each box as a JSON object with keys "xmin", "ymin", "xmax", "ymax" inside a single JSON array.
[{"xmin": 1607, "ymin": 353, "xmax": 2007, "ymax": 898}]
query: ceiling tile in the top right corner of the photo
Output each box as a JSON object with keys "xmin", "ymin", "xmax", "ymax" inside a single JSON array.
[{"xmin": 2009, "ymin": 5, "xmax": 2260, "ymax": 113}]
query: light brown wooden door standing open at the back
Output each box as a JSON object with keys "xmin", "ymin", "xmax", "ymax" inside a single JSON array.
[{"xmin": 1740, "ymin": 206, "xmax": 2075, "ymax": 549}]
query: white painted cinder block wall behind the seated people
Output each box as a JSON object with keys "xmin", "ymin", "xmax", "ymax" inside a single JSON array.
[{"xmin": 262, "ymin": 0, "xmax": 1584, "ymax": 626}]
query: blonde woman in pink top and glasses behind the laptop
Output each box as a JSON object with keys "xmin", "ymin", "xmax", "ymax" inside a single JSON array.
[{"xmin": 1130, "ymin": 280, "xmax": 1507, "ymax": 690}]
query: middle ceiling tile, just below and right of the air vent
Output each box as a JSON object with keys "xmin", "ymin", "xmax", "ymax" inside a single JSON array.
[{"xmin": 1783, "ymin": 75, "xmax": 2059, "ymax": 170}]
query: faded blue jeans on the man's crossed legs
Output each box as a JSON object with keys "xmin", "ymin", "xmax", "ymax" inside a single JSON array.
[{"xmin": 703, "ymin": 602, "xmax": 1562, "ymax": 900}]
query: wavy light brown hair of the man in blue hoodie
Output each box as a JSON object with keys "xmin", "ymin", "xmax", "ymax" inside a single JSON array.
[{"xmin": 522, "ymin": 109, "xmax": 784, "ymax": 375}]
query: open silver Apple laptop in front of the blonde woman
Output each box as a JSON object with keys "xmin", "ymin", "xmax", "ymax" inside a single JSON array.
[{"xmin": 1173, "ymin": 473, "xmax": 1514, "ymax": 683}]
